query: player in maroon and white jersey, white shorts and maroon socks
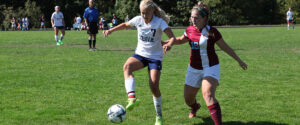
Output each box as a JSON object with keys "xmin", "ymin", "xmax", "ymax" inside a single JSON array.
[{"xmin": 164, "ymin": 4, "xmax": 247, "ymax": 125}]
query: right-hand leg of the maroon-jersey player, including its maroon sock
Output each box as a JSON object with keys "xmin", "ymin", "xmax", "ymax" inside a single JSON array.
[{"xmin": 202, "ymin": 76, "xmax": 222, "ymax": 125}]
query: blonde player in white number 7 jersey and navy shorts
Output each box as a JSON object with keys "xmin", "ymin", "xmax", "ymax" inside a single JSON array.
[{"xmin": 103, "ymin": 0, "xmax": 175, "ymax": 125}]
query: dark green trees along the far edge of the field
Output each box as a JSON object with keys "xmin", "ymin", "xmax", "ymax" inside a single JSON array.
[{"xmin": 0, "ymin": 0, "xmax": 300, "ymax": 28}]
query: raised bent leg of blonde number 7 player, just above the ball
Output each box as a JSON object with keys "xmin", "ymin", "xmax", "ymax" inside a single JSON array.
[{"xmin": 123, "ymin": 55, "xmax": 145, "ymax": 111}]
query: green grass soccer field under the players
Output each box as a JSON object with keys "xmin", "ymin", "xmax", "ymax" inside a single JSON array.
[{"xmin": 0, "ymin": 27, "xmax": 300, "ymax": 125}]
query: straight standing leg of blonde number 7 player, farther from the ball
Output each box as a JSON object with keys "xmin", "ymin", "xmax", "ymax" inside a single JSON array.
[{"xmin": 149, "ymin": 69, "xmax": 163, "ymax": 125}]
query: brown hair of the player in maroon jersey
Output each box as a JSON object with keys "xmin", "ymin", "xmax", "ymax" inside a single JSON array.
[{"xmin": 192, "ymin": 3, "xmax": 215, "ymax": 37}]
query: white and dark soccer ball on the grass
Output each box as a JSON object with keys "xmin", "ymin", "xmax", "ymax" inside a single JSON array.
[{"xmin": 107, "ymin": 104, "xmax": 126, "ymax": 123}]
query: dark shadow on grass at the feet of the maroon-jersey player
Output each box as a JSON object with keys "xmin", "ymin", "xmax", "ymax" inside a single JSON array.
[{"xmin": 194, "ymin": 117, "xmax": 288, "ymax": 125}]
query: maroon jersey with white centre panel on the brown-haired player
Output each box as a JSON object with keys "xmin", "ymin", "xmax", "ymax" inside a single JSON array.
[{"xmin": 184, "ymin": 25, "xmax": 222, "ymax": 70}]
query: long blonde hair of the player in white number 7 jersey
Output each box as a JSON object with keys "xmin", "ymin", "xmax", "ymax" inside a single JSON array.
[{"xmin": 140, "ymin": 0, "xmax": 170, "ymax": 23}]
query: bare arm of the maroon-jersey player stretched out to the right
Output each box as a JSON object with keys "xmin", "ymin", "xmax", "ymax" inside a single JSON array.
[{"xmin": 216, "ymin": 38, "xmax": 247, "ymax": 70}]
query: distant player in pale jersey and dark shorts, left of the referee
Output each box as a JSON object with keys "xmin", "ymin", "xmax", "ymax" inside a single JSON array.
[{"xmin": 51, "ymin": 6, "xmax": 65, "ymax": 46}]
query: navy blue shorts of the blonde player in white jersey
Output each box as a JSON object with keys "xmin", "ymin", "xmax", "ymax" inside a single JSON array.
[{"xmin": 132, "ymin": 54, "xmax": 162, "ymax": 71}]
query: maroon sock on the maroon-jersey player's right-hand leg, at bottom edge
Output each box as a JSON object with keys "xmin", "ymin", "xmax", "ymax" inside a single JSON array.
[{"xmin": 208, "ymin": 103, "xmax": 222, "ymax": 125}]
